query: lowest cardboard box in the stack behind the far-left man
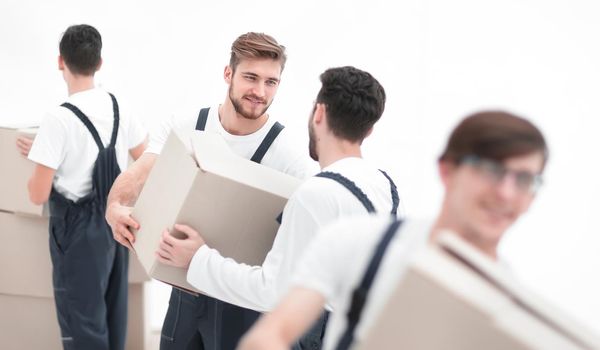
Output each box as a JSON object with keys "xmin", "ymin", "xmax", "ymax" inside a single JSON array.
[{"xmin": 0, "ymin": 283, "xmax": 149, "ymax": 350}]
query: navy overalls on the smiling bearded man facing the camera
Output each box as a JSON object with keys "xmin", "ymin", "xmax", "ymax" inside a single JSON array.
[{"xmin": 160, "ymin": 108, "xmax": 283, "ymax": 350}]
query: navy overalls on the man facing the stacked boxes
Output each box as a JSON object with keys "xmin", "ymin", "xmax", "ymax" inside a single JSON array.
[{"xmin": 49, "ymin": 94, "xmax": 128, "ymax": 350}]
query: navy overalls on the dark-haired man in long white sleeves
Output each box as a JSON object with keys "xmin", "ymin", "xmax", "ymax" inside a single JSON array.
[{"xmin": 293, "ymin": 170, "xmax": 400, "ymax": 350}]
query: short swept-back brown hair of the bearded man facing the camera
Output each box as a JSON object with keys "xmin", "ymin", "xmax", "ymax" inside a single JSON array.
[{"xmin": 229, "ymin": 32, "xmax": 287, "ymax": 71}]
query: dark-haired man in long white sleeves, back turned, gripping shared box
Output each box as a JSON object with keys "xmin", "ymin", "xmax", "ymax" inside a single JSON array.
[{"xmin": 158, "ymin": 67, "xmax": 399, "ymax": 349}]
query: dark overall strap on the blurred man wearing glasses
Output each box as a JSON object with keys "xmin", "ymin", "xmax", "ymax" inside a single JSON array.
[{"xmin": 336, "ymin": 221, "xmax": 402, "ymax": 350}]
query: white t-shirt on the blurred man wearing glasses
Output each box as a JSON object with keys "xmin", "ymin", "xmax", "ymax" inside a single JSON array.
[{"xmin": 290, "ymin": 215, "xmax": 432, "ymax": 349}]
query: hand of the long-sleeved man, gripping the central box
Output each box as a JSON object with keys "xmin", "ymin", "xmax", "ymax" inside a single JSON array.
[{"xmin": 156, "ymin": 224, "xmax": 205, "ymax": 268}]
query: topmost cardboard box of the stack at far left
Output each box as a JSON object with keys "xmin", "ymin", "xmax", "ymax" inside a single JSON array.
[{"xmin": 0, "ymin": 127, "xmax": 48, "ymax": 216}]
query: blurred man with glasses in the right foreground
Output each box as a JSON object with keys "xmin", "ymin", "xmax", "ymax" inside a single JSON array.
[{"xmin": 240, "ymin": 111, "xmax": 548, "ymax": 350}]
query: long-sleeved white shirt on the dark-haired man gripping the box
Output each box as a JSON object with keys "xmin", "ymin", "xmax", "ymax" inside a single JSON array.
[{"xmin": 187, "ymin": 157, "xmax": 404, "ymax": 311}]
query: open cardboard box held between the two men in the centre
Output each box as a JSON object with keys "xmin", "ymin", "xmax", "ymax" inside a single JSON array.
[{"xmin": 133, "ymin": 131, "xmax": 300, "ymax": 291}]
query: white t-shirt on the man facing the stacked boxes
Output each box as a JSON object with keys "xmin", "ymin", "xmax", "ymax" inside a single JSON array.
[{"xmin": 29, "ymin": 88, "xmax": 147, "ymax": 201}]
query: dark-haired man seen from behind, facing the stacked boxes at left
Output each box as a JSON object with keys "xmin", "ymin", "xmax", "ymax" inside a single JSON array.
[{"xmin": 18, "ymin": 24, "xmax": 147, "ymax": 350}]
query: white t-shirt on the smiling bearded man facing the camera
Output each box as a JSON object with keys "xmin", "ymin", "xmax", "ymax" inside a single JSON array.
[{"xmin": 146, "ymin": 105, "xmax": 318, "ymax": 179}]
